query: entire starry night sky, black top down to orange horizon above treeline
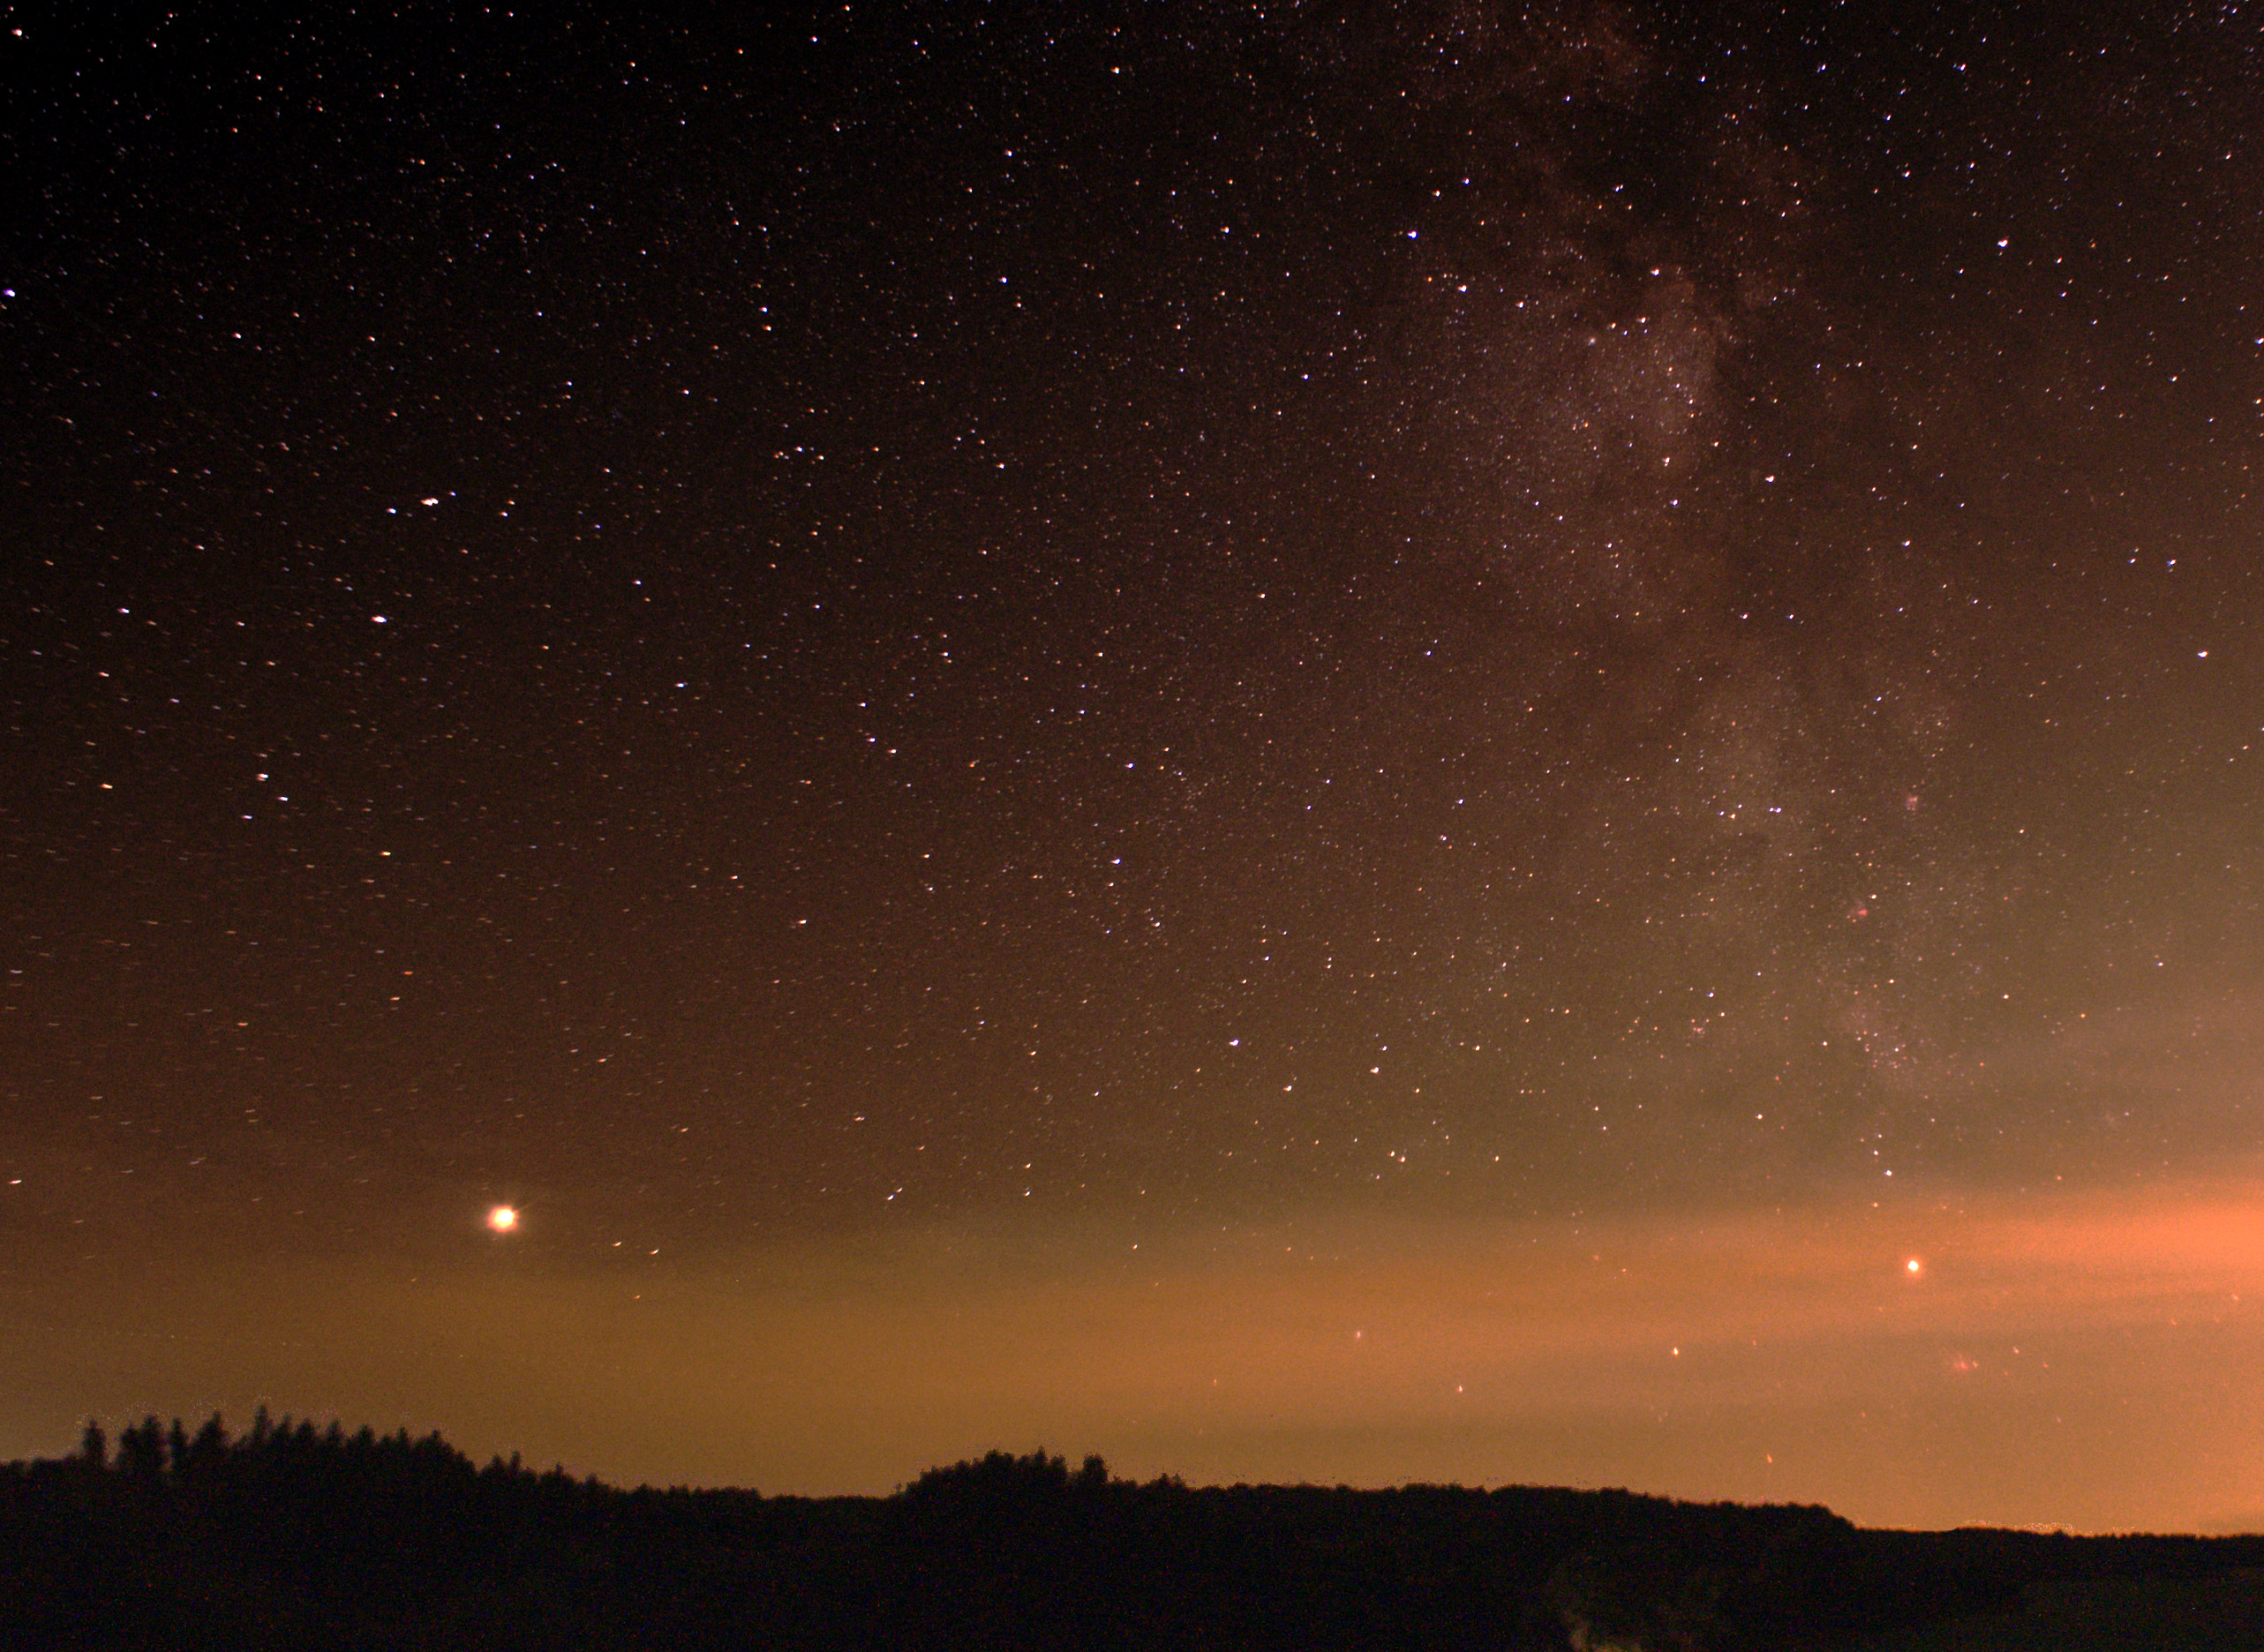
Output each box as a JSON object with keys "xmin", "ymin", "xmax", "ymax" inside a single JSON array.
[{"xmin": 0, "ymin": 0, "xmax": 2264, "ymax": 1528}]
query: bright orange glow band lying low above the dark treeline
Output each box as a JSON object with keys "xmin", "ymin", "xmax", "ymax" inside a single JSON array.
[{"xmin": 0, "ymin": 1182, "xmax": 2264, "ymax": 1530}]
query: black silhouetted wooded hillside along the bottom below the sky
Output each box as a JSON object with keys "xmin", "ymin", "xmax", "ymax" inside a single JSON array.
[{"xmin": 0, "ymin": 1416, "xmax": 2264, "ymax": 1652}]
